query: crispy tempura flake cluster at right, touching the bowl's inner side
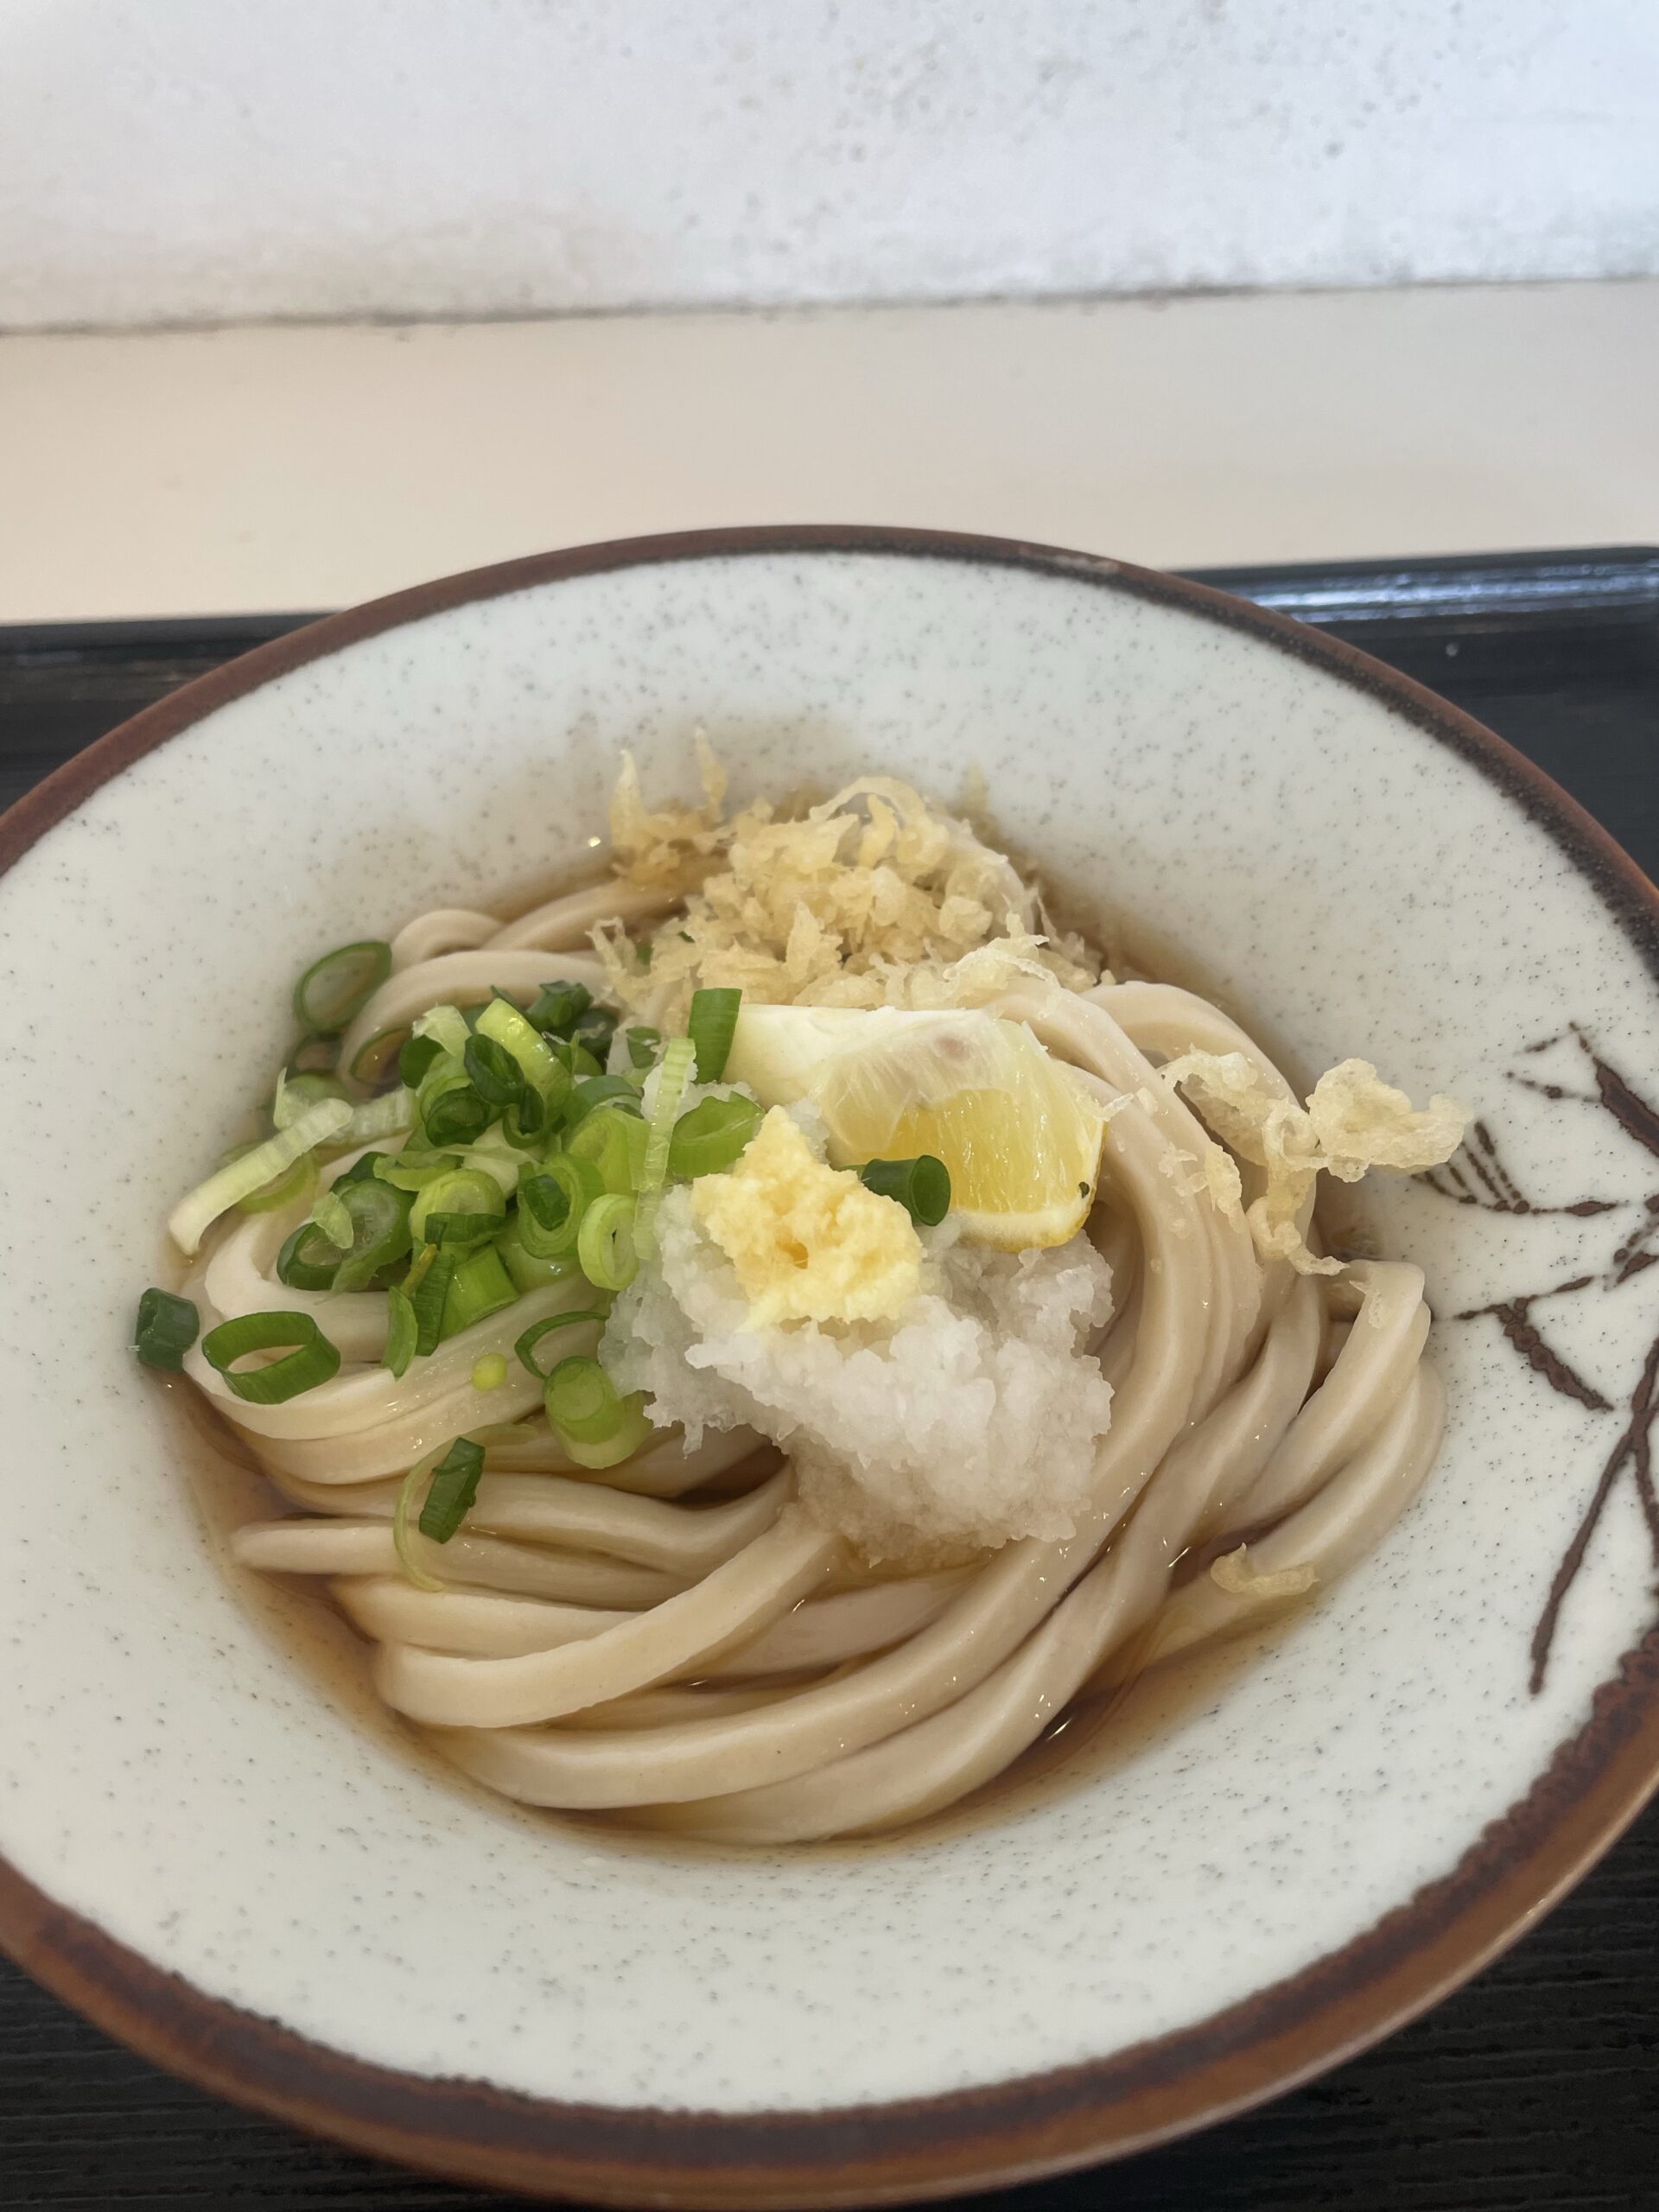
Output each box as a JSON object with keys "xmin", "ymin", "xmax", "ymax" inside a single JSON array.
[{"xmin": 1159, "ymin": 1053, "xmax": 1469, "ymax": 1274}]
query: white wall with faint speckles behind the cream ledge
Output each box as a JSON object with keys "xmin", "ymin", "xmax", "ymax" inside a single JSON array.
[{"xmin": 0, "ymin": 0, "xmax": 1659, "ymax": 327}]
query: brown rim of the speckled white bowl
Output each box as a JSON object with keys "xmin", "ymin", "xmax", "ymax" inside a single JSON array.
[{"xmin": 0, "ymin": 524, "xmax": 1659, "ymax": 2208}]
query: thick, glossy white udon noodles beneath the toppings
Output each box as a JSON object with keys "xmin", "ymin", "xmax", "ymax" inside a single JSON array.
[{"xmin": 145, "ymin": 769, "xmax": 1455, "ymax": 1845}]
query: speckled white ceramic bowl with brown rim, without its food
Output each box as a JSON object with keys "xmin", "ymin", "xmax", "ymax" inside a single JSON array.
[{"xmin": 0, "ymin": 529, "xmax": 1659, "ymax": 2205}]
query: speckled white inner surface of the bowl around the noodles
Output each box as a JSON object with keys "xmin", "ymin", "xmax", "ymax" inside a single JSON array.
[{"xmin": 0, "ymin": 539, "xmax": 1655, "ymax": 2110}]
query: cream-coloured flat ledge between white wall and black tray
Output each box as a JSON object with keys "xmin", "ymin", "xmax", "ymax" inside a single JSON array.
[{"xmin": 0, "ymin": 281, "xmax": 1659, "ymax": 621}]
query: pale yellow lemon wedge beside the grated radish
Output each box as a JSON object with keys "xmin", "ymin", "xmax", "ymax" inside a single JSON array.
[{"xmin": 726, "ymin": 1007, "xmax": 1106, "ymax": 1252}]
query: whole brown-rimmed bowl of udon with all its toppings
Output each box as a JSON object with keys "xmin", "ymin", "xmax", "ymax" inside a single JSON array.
[{"xmin": 0, "ymin": 529, "xmax": 1659, "ymax": 2205}]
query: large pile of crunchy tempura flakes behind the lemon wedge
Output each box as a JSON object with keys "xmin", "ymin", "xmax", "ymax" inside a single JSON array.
[{"xmin": 593, "ymin": 741, "xmax": 1099, "ymax": 1027}]
